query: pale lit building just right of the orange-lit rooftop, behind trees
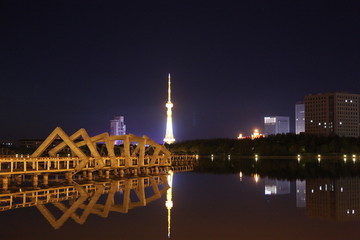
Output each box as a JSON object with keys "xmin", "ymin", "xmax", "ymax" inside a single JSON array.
[{"xmin": 264, "ymin": 116, "xmax": 290, "ymax": 136}]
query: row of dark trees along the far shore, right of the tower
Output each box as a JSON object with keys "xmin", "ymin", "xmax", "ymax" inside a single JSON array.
[{"xmin": 168, "ymin": 133, "xmax": 360, "ymax": 156}]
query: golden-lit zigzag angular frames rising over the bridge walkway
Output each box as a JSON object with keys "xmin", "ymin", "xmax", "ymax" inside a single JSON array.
[{"xmin": 31, "ymin": 127, "xmax": 171, "ymax": 171}]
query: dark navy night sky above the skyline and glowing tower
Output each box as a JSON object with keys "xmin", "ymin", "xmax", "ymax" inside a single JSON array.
[{"xmin": 0, "ymin": 0, "xmax": 360, "ymax": 142}]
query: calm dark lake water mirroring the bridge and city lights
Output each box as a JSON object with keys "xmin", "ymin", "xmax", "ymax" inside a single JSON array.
[{"xmin": 0, "ymin": 169, "xmax": 360, "ymax": 240}]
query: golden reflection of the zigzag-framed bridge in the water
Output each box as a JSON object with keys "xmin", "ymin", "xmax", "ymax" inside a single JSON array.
[{"xmin": 0, "ymin": 175, "xmax": 169, "ymax": 229}]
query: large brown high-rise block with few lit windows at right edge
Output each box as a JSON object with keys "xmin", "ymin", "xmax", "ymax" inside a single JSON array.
[{"xmin": 304, "ymin": 92, "xmax": 360, "ymax": 137}]
